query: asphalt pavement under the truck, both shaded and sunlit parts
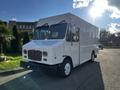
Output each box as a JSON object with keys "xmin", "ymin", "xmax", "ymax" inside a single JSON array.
[{"xmin": 0, "ymin": 49, "xmax": 120, "ymax": 90}]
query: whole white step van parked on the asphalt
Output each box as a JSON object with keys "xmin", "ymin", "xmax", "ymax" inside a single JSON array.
[{"xmin": 21, "ymin": 13, "xmax": 99, "ymax": 77}]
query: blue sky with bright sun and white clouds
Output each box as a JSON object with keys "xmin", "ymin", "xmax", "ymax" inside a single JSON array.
[{"xmin": 0, "ymin": 0, "xmax": 120, "ymax": 33}]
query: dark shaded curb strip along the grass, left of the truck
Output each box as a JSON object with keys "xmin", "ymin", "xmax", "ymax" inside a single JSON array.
[{"xmin": 0, "ymin": 68, "xmax": 27, "ymax": 76}]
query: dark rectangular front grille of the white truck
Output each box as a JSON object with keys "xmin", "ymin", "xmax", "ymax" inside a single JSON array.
[{"xmin": 28, "ymin": 50, "xmax": 42, "ymax": 61}]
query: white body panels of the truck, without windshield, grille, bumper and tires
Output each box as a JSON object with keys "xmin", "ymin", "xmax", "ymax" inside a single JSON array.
[{"xmin": 22, "ymin": 13, "xmax": 99, "ymax": 76}]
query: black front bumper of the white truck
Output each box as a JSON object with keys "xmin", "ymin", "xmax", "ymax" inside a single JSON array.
[{"xmin": 20, "ymin": 61, "xmax": 60, "ymax": 70}]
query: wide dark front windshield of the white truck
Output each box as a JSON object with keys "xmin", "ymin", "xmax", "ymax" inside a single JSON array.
[{"xmin": 34, "ymin": 23, "xmax": 67, "ymax": 40}]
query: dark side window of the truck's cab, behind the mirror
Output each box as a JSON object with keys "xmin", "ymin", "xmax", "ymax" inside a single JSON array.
[{"xmin": 66, "ymin": 26, "xmax": 80, "ymax": 42}]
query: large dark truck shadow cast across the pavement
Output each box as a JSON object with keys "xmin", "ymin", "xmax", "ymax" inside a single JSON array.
[{"xmin": 0, "ymin": 62, "xmax": 104, "ymax": 90}]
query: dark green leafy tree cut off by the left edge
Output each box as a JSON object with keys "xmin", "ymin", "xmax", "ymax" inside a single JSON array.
[{"xmin": 0, "ymin": 20, "xmax": 9, "ymax": 54}]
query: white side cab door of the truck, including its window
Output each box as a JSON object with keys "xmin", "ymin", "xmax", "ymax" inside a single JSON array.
[{"xmin": 66, "ymin": 25, "xmax": 80, "ymax": 66}]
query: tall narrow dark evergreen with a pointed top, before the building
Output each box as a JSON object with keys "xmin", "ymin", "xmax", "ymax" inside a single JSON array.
[{"xmin": 11, "ymin": 25, "xmax": 20, "ymax": 53}]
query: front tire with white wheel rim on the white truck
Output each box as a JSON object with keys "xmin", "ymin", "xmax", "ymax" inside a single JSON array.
[{"xmin": 59, "ymin": 60, "xmax": 72, "ymax": 77}]
